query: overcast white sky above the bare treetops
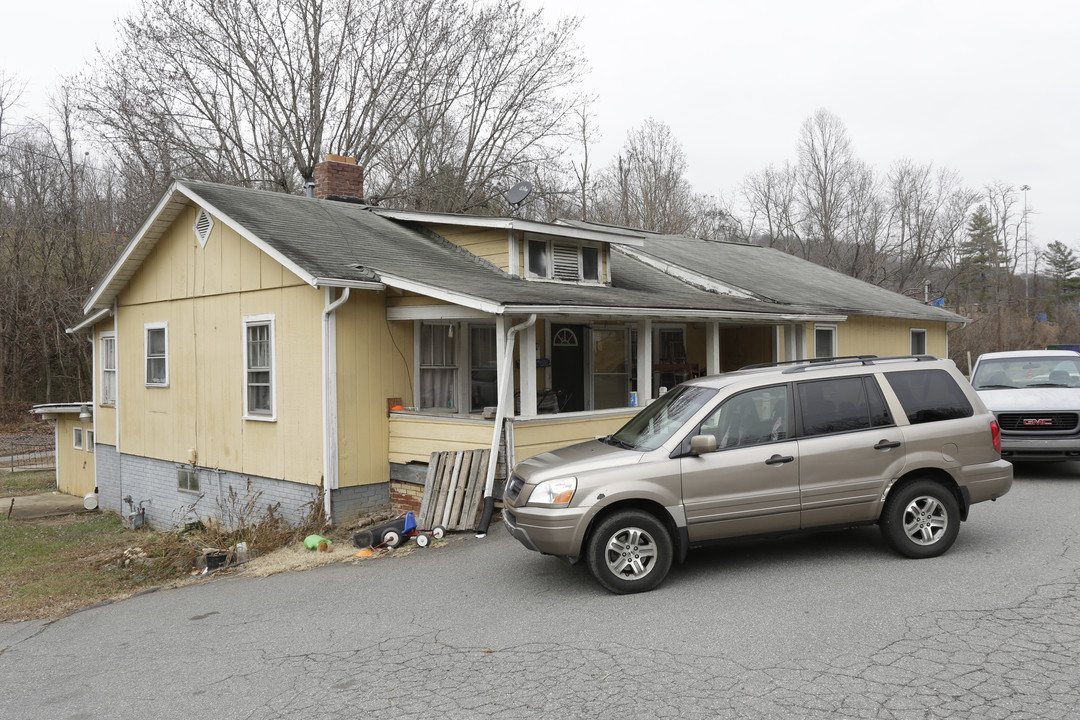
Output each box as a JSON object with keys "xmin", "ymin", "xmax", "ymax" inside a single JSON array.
[{"xmin": 0, "ymin": 0, "xmax": 1080, "ymax": 248}]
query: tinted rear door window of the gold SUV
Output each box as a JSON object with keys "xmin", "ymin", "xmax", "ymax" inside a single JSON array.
[{"xmin": 798, "ymin": 377, "xmax": 892, "ymax": 435}]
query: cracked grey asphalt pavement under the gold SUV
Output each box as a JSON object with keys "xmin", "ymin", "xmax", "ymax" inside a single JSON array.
[{"xmin": 0, "ymin": 463, "xmax": 1080, "ymax": 720}]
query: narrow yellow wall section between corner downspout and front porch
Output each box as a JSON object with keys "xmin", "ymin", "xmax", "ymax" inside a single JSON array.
[{"xmin": 336, "ymin": 290, "xmax": 412, "ymax": 487}]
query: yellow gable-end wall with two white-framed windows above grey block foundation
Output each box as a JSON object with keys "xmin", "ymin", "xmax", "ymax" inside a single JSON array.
[{"xmin": 116, "ymin": 208, "xmax": 323, "ymax": 484}]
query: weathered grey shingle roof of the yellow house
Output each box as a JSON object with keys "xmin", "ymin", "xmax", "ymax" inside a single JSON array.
[{"xmin": 84, "ymin": 180, "xmax": 961, "ymax": 322}]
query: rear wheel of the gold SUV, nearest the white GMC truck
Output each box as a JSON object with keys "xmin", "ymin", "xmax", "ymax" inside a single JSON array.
[{"xmin": 881, "ymin": 480, "xmax": 960, "ymax": 558}]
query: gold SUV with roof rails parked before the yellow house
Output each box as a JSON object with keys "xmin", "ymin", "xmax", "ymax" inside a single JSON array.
[{"xmin": 502, "ymin": 355, "xmax": 1012, "ymax": 593}]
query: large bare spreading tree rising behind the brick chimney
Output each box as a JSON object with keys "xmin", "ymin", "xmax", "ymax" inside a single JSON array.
[{"xmin": 78, "ymin": 0, "xmax": 583, "ymax": 210}]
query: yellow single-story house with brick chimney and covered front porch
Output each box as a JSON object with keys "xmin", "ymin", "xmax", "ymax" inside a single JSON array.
[{"xmin": 62, "ymin": 155, "xmax": 964, "ymax": 527}]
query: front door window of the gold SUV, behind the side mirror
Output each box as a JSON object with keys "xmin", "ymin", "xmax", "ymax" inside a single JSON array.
[{"xmin": 696, "ymin": 385, "xmax": 791, "ymax": 450}]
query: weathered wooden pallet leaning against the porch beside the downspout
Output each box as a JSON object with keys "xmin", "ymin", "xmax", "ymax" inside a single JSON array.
[{"xmin": 417, "ymin": 450, "xmax": 490, "ymax": 530}]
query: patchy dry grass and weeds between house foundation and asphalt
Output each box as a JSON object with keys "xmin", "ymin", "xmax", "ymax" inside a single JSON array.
[{"xmin": 0, "ymin": 483, "xmax": 451, "ymax": 622}]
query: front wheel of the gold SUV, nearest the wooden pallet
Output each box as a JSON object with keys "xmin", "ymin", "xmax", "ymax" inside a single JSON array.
[{"xmin": 586, "ymin": 510, "xmax": 672, "ymax": 595}]
